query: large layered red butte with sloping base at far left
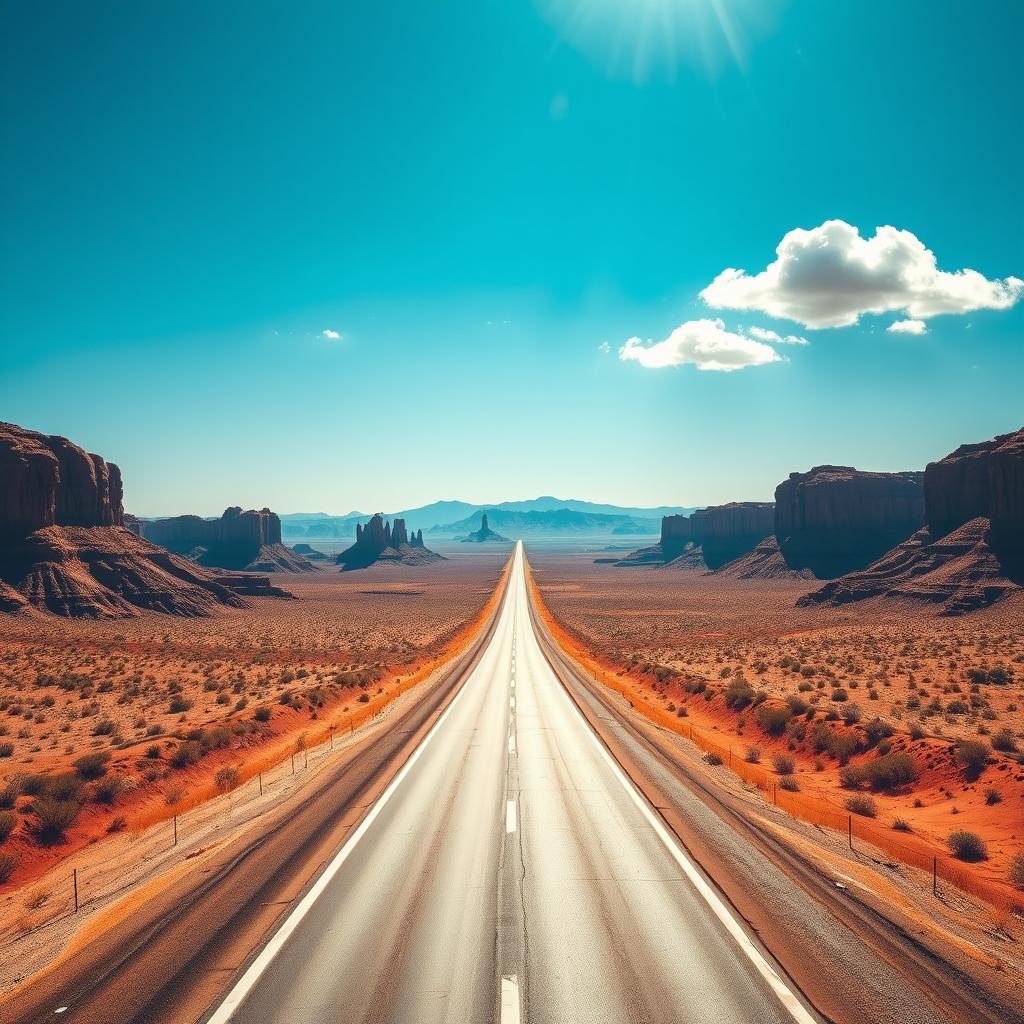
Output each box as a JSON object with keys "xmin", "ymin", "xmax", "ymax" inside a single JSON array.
[{"xmin": 0, "ymin": 423, "xmax": 244, "ymax": 618}]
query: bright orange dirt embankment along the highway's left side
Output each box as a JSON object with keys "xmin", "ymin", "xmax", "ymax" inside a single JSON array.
[{"xmin": 0, "ymin": 560, "xmax": 511, "ymax": 891}]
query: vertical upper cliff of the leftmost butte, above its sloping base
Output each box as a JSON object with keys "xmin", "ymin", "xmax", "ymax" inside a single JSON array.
[{"xmin": 0, "ymin": 423, "xmax": 124, "ymax": 542}]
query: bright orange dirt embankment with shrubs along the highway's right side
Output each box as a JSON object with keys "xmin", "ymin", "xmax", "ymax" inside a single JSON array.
[{"xmin": 527, "ymin": 565, "xmax": 1024, "ymax": 910}]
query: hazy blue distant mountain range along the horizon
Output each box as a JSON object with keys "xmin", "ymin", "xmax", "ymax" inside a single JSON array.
[{"xmin": 281, "ymin": 495, "xmax": 693, "ymax": 540}]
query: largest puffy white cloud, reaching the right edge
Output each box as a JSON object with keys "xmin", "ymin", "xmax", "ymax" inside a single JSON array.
[{"xmin": 700, "ymin": 220, "xmax": 1024, "ymax": 328}]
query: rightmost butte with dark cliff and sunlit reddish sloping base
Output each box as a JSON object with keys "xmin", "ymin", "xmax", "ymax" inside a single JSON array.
[{"xmin": 799, "ymin": 429, "xmax": 1024, "ymax": 614}]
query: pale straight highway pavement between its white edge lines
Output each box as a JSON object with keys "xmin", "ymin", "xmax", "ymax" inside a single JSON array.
[{"xmin": 207, "ymin": 545, "xmax": 817, "ymax": 1024}]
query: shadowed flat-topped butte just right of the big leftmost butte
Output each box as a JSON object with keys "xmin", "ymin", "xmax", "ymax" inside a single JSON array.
[{"xmin": 145, "ymin": 506, "xmax": 315, "ymax": 572}]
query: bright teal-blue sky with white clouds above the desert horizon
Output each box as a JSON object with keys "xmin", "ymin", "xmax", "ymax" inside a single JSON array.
[{"xmin": 0, "ymin": 0, "xmax": 1024, "ymax": 515}]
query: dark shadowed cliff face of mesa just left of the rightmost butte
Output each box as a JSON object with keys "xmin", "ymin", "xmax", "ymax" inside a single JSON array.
[{"xmin": 775, "ymin": 466, "xmax": 925, "ymax": 579}]
